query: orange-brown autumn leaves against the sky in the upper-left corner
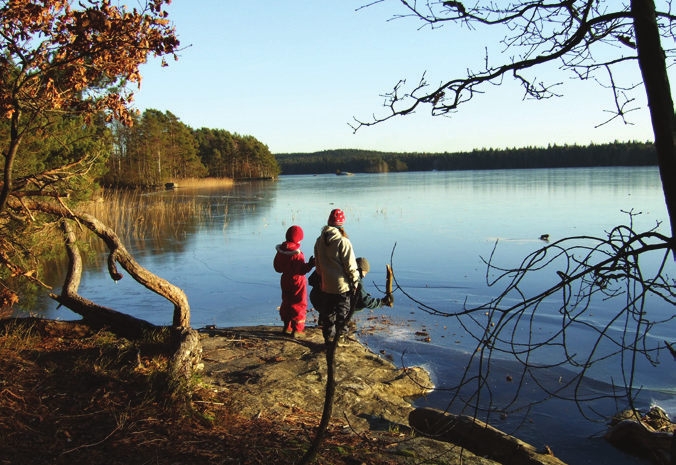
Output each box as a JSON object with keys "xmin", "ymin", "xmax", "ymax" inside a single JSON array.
[{"xmin": 0, "ymin": 0, "xmax": 179, "ymax": 122}]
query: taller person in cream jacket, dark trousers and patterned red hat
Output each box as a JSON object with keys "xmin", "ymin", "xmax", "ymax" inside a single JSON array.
[{"xmin": 315, "ymin": 209, "xmax": 359, "ymax": 343}]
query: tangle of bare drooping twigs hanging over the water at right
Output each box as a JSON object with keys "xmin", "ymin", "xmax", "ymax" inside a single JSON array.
[{"xmin": 393, "ymin": 215, "xmax": 676, "ymax": 428}]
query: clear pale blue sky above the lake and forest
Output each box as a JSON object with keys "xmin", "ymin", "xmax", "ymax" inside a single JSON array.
[{"xmin": 135, "ymin": 0, "xmax": 673, "ymax": 153}]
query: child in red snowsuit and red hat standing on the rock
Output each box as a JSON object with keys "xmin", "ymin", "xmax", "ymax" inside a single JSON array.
[{"xmin": 273, "ymin": 226, "xmax": 315, "ymax": 338}]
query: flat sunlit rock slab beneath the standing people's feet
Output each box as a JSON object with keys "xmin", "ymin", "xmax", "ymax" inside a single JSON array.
[{"xmin": 200, "ymin": 326, "xmax": 432, "ymax": 430}]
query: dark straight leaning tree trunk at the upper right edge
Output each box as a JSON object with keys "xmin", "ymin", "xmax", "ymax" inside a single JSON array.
[{"xmin": 631, "ymin": 0, "xmax": 676, "ymax": 236}]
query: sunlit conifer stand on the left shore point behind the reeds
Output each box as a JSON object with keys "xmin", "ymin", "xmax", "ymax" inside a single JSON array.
[{"xmin": 102, "ymin": 109, "xmax": 279, "ymax": 187}]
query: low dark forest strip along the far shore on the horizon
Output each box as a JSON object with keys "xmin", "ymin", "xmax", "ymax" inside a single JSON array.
[{"xmin": 275, "ymin": 141, "xmax": 657, "ymax": 174}]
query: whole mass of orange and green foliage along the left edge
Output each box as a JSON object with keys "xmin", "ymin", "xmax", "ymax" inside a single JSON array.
[{"xmin": 0, "ymin": 0, "xmax": 179, "ymax": 312}]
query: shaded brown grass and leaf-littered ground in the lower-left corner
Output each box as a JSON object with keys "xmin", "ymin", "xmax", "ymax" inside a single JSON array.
[{"xmin": 0, "ymin": 320, "xmax": 402, "ymax": 465}]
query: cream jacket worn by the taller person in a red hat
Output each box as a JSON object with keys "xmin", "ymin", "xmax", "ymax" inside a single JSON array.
[{"xmin": 315, "ymin": 226, "xmax": 359, "ymax": 294}]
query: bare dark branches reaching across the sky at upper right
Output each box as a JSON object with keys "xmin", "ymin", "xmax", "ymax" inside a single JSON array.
[{"xmin": 350, "ymin": 0, "xmax": 652, "ymax": 132}]
